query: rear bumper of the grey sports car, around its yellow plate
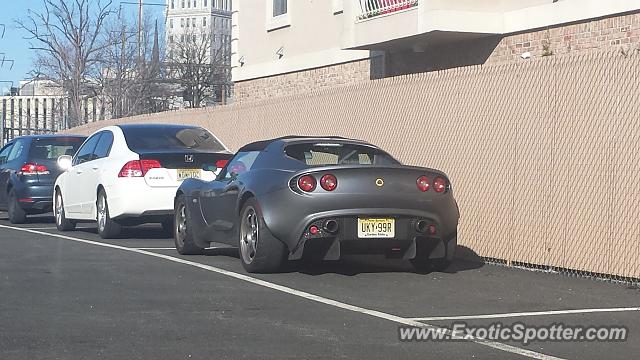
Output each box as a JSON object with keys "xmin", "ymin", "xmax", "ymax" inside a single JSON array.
[{"xmin": 259, "ymin": 189, "xmax": 460, "ymax": 260}]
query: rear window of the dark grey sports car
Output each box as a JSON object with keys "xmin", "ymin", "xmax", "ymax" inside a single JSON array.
[{"xmin": 284, "ymin": 143, "xmax": 399, "ymax": 167}]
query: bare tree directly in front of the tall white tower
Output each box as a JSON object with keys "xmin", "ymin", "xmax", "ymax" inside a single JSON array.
[{"xmin": 166, "ymin": 30, "xmax": 231, "ymax": 108}]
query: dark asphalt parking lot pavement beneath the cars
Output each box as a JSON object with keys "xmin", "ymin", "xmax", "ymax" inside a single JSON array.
[{"xmin": 0, "ymin": 213, "xmax": 640, "ymax": 359}]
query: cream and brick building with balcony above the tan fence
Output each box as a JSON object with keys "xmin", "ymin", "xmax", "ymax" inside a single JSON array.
[{"xmin": 231, "ymin": 0, "xmax": 640, "ymax": 101}]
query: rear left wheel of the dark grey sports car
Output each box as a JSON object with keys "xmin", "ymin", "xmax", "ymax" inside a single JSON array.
[{"xmin": 238, "ymin": 198, "xmax": 287, "ymax": 273}]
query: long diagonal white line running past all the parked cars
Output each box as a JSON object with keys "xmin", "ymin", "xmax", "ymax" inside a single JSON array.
[{"xmin": 0, "ymin": 225, "xmax": 563, "ymax": 360}]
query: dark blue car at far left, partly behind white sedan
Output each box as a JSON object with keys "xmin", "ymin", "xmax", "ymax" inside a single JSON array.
[{"xmin": 0, "ymin": 135, "xmax": 85, "ymax": 224}]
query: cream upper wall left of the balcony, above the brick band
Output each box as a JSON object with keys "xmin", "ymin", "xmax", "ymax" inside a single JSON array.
[{"xmin": 232, "ymin": 0, "xmax": 369, "ymax": 81}]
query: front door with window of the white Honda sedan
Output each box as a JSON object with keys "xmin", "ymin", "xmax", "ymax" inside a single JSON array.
[{"xmin": 63, "ymin": 133, "xmax": 102, "ymax": 218}]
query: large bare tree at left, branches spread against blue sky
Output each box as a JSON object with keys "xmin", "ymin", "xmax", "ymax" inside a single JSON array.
[{"xmin": 16, "ymin": 0, "xmax": 113, "ymax": 127}]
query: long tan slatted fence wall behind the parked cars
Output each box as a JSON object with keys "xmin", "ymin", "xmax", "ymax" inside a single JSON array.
[{"xmin": 66, "ymin": 52, "xmax": 640, "ymax": 278}]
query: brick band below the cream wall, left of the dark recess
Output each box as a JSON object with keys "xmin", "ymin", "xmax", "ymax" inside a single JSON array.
[{"xmin": 234, "ymin": 59, "xmax": 371, "ymax": 102}]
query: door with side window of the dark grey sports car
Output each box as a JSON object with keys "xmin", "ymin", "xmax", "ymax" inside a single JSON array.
[{"xmin": 200, "ymin": 151, "xmax": 260, "ymax": 231}]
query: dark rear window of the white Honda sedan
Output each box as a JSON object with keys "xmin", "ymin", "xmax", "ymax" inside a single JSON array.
[{"xmin": 122, "ymin": 126, "xmax": 225, "ymax": 151}]
